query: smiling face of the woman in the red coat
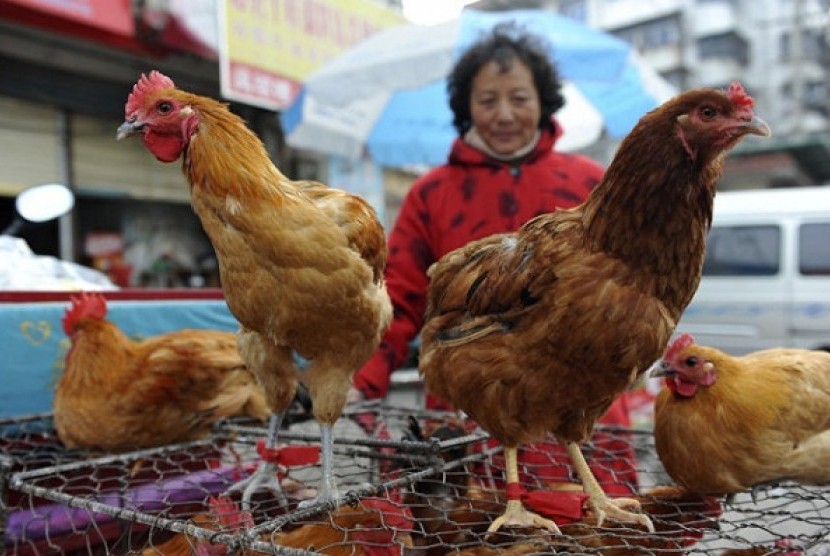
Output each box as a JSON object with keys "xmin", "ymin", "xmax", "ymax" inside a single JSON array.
[{"xmin": 470, "ymin": 59, "xmax": 542, "ymax": 155}]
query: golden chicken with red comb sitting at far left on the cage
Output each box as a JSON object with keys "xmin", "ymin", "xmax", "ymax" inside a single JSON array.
[{"xmin": 53, "ymin": 293, "xmax": 270, "ymax": 452}]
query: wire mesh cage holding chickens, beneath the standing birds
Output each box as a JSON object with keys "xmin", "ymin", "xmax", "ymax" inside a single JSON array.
[{"xmin": 0, "ymin": 403, "xmax": 830, "ymax": 555}]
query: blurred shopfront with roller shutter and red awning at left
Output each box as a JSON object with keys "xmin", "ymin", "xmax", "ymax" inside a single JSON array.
[{"xmin": 0, "ymin": 0, "xmax": 400, "ymax": 287}]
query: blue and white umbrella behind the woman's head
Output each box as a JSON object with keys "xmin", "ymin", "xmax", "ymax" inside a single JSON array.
[{"xmin": 282, "ymin": 9, "xmax": 675, "ymax": 167}]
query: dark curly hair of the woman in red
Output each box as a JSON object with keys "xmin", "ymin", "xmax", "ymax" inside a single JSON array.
[{"xmin": 447, "ymin": 22, "xmax": 565, "ymax": 136}]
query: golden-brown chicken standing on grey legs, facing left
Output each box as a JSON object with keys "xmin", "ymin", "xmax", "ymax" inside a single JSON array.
[{"xmin": 118, "ymin": 71, "xmax": 392, "ymax": 502}]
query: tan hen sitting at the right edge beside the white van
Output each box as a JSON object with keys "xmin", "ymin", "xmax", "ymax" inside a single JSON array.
[{"xmin": 651, "ymin": 334, "xmax": 830, "ymax": 494}]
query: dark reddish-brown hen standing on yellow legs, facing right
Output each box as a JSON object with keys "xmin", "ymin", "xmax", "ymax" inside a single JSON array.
[{"xmin": 420, "ymin": 83, "xmax": 769, "ymax": 531}]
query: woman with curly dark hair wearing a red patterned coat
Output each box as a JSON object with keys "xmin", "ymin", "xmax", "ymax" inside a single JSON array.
[{"xmin": 351, "ymin": 24, "xmax": 636, "ymax": 494}]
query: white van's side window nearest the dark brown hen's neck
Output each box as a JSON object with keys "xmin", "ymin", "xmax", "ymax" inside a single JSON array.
[{"xmin": 703, "ymin": 225, "xmax": 781, "ymax": 276}]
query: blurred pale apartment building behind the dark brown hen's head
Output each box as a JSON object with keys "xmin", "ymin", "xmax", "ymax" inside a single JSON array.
[{"xmin": 537, "ymin": 0, "xmax": 830, "ymax": 189}]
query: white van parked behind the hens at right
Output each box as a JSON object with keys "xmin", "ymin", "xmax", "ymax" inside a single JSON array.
[{"xmin": 677, "ymin": 186, "xmax": 830, "ymax": 355}]
